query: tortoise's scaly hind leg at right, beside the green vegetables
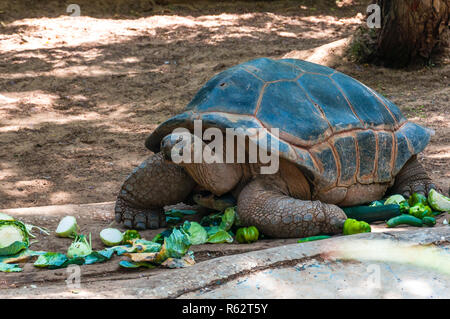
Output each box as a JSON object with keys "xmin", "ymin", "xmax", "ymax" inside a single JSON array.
[{"xmin": 389, "ymin": 156, "xmax": 439, "ymax": 198}]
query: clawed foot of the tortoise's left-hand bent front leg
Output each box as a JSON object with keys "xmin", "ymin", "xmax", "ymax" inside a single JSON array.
[{"xmin": 115, "ymin": 198, "xmax": 166, "ymax": 230}]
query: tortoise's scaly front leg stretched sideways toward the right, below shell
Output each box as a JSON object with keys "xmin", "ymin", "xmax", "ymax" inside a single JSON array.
[{"xmin": 238, "ymin": 177, "xmax": 347, "ymax": 238}]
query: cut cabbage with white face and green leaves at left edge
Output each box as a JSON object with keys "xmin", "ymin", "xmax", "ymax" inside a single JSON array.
[{"xmin": 0, "ymin": 220, "xmax": 29, "ymax": 256}]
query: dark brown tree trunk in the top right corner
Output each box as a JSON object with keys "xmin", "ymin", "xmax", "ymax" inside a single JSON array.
[{"xmin": 354, "ymin": 0, "xmax": 450, "ymax": 67}]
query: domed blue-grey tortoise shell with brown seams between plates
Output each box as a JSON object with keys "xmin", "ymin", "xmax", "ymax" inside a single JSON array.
[{"xmin": 146, "ymin": 58, "xmax": 431, "ymax": 189}]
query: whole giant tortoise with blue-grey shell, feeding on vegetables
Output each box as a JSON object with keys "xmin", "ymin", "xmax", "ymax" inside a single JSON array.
[{"xmin": 115, "ymin": 58, "xmax": 435, "ymax": 237}]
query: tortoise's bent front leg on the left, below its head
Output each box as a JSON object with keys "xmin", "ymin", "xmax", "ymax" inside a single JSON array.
[{"xmin": 115, "ymin": 153, "xmax": 195, "ymax": 229}]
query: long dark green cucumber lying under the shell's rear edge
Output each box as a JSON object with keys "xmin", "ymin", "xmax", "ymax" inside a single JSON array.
[{"xmin": 342, "ymin": 204, "xmax": 401, "ymax": 223}]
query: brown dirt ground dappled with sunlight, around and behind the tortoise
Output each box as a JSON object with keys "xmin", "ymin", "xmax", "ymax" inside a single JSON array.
[{"xmin": 0, "ymin": 0, "xmax": 450, "ymax": 296}]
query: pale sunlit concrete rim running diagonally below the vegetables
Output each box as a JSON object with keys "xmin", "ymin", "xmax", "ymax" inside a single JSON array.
[{"xmin": 111, "ymin": 226, "xmax": 450, "ymax": 298}]
